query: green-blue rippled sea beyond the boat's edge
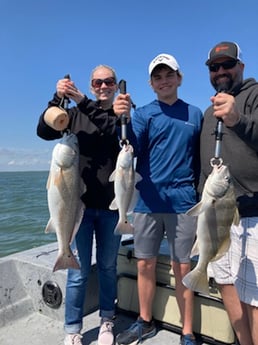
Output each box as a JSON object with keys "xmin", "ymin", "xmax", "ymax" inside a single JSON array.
[{"xmin": 0, "ymin": 171, "xmax": 56, "ymax": 257}]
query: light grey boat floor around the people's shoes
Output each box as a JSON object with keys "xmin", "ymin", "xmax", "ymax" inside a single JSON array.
[{"xmin": 0, "ymin": 311, "xmax": 189, "ymax": 345}]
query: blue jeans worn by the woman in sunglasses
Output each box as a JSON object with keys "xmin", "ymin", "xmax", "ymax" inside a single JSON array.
[{"xmin": 65, "ymin": 208, "xmax": 121, "ymax": 333}]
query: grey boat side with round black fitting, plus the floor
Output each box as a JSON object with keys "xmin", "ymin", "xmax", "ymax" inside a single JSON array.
[{"xmin": 0, "ymin": 243, "xmax": 235, "ymax": 345}]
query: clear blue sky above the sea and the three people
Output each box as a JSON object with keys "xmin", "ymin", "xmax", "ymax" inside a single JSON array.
[{"xmin": 0, "ymin": 0, "xmax": 258, "ymax": 171}]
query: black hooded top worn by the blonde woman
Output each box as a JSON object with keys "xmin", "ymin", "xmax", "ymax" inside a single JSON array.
[{"xmin": 37, "ymin": 94, "xmax": 120, "ymax": 209}]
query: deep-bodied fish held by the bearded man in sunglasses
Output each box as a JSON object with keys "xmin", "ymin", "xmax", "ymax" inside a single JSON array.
[{"xmin": 182, "ymin": 164, "xmax": 240, "ymax": 294}]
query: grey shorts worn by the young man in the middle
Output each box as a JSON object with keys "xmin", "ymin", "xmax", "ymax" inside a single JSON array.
[{"xmin": 133, "ymin": 213, "xmax": 197, "ymax": 263}]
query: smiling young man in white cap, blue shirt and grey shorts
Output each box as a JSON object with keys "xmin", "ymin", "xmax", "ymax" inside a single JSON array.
[{"xmin": 114, "ymin": 54, "xmax": 203, "ymax": 345}]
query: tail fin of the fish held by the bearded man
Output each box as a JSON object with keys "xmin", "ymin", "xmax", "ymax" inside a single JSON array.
[{"xmin": 182, "ymin": 268, "xmax": 209, "ymax": 295}]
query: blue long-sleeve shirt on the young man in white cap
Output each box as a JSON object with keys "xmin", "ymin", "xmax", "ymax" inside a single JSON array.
[{"xmin": 131, "ymin": 99, "xmax": 203, "ymax": 213}]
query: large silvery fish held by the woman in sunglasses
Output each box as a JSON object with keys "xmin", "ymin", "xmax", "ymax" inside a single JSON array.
[{"xmin": 45, "ymin": 133, "xmax": 86, "ymax": 272}]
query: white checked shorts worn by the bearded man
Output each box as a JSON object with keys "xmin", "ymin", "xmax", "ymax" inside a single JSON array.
[{"xmin": 210, "ymin": 217, "xmax": 258, "ymax": 307}]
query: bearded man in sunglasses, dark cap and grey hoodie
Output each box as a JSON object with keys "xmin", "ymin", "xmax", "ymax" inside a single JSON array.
[{"xmin": 199, "ymin": 42, "xmax": 258, "ymax": 345}]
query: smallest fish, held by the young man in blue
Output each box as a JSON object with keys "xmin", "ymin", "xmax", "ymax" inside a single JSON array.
[{"xmin": 109, "ymin": 144, "xmax": 142, "ymax": 235}]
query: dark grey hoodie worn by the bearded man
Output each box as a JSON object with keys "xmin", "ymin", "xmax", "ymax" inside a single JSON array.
[{"xmin": 198, "ymin": 78, "xmax": 258, "ymax": 217}]
